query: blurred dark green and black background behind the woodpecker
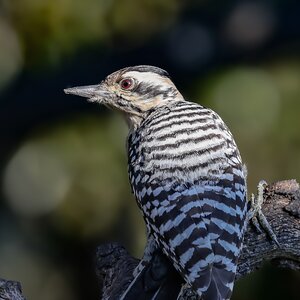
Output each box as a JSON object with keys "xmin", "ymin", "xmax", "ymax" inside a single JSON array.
[{"xmin": 0, "ymin": 0, "xmax": 300, "ymax": 300}]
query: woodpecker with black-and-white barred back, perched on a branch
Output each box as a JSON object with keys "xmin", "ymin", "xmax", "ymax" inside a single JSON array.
[{"xmin": 65, "ymin": 65, "xmax": 247, "ymax": 300}]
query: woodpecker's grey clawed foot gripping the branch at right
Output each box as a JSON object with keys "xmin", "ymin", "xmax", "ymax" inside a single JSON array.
[{"xmin": 248, "ymin": 180, "xmax": 280, "ymax": 247}]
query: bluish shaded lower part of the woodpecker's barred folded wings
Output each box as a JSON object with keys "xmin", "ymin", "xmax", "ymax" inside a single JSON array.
[{"xmin": 142, "ymin": 167, "xmax": 246, "ymax": 299}]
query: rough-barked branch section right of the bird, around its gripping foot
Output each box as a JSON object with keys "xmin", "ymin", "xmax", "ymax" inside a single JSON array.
[{"xmin": 237, "ymin": 180, "xmax": 300, "ymax": 278}]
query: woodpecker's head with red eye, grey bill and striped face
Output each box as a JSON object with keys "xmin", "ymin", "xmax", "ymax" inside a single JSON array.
[{"xmin": 64, "ymin": 66, "xmax": 183, "ymax": 127}]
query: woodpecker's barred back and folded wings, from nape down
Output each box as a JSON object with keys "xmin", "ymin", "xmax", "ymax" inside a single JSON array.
[{"xmin": 128, "ymin": 101, "xmax": 246, "ymax": 300}]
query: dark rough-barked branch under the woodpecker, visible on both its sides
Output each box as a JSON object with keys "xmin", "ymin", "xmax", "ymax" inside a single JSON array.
[{"xmin": 97, "ymin": 180, "xmax": 300, "ymax": 300}]
